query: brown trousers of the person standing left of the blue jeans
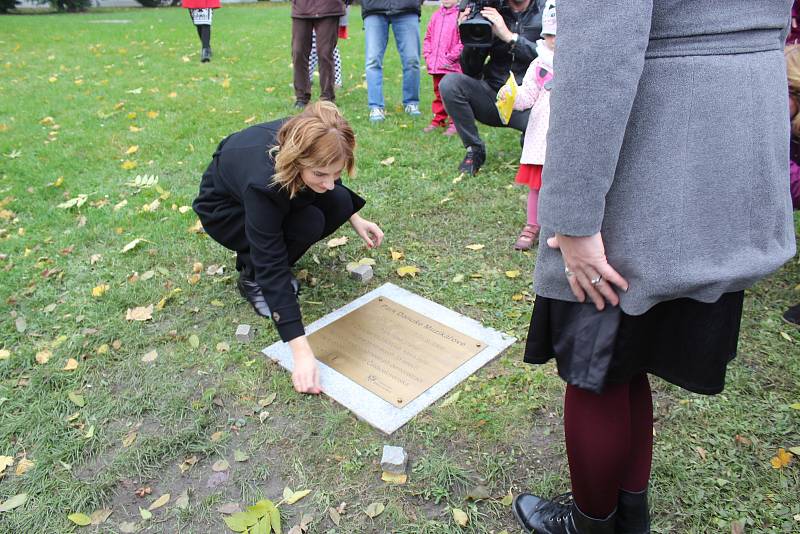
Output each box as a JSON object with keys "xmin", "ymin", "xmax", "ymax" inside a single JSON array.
[{"xmin": 292, "ymin": 17, "xmax": 339, "ymax": 103}]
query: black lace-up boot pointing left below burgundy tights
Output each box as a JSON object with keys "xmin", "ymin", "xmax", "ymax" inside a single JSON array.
[{"xmin": 511, "ymin": 493, "xmax": 616, "ymax": 534}]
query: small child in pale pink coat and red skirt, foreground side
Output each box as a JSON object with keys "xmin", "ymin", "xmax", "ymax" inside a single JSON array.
[{"xmin": 510, "ymin": 0, "xmax": 556, "ymax": 250}]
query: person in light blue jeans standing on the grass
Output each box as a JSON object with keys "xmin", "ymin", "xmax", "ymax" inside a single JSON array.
[{"xmin": 361, "ymin": 0, "xmax": 422, "ymax": 122}]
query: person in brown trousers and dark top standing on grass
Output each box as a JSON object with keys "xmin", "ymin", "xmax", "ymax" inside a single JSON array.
[{"xmin": 292, "ymin": 0, "xmax": 345, "ymax": 109}]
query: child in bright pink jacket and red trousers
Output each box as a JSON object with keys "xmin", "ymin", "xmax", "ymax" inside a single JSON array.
[{"xmin": 422, "ymin": 0, "xmax": 463, "ymax": 135}]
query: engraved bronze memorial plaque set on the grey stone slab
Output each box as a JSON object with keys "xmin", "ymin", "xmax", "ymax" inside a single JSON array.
[{"xmin": 308, "ymin": 297, "xmax": 486, "ymax": 408}]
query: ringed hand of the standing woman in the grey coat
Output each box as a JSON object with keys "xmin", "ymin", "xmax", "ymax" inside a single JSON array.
[{"xmin": 547, "ymin": 232, "xmax": 628, "ymax": 310}]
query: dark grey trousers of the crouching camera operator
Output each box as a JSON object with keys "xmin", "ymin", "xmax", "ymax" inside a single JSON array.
[{"xmin": 439, "ymin": 73, "xmax": 530, "ymax": 148}]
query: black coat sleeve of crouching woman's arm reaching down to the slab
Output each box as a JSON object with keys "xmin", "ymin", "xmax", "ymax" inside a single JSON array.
[{"xmin": 242, "ymin": 186, "xmax": 305, "ymax": 341}]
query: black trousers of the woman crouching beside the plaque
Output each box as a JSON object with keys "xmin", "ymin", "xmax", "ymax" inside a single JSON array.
[{"xmin": 194, "ymin": 185, "xmax": 353, "ymax": 278}]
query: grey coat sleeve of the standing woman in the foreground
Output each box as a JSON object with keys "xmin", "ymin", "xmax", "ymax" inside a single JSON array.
[{"xmin": 539, "ymin": 0, "xmax": 653, "ymax": 236}]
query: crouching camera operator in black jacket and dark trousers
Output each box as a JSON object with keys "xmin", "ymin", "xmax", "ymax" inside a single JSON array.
[{"xmin": 439, "ymin": 0, "xmax": 545, "ymax": 175}]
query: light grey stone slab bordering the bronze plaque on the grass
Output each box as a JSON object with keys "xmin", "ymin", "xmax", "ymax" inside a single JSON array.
[{"xmin": 262, "ymin": 283, "xmax": 516, "ymax": 434}]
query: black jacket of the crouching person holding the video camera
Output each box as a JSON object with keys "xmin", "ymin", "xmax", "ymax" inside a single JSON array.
[{"xmin": 461, "ymin": 0, "xmax": 545, "ymax": 91}]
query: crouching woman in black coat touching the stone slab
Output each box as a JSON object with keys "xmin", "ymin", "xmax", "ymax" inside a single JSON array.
[{"xmin": 192, "ymin": 102, "xmax": 383, "ymax": 393}]
